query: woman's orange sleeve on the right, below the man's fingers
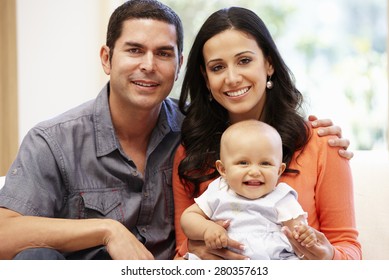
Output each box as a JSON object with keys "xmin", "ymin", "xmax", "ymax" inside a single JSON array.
[{"xmin": 315, "ymin": 130, "xmax": 362, "ymax": 259}]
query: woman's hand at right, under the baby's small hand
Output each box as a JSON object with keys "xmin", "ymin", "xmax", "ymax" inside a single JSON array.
[{"xmin": 282, "ymin": 226, "xmax": 334, "ymax": 260}]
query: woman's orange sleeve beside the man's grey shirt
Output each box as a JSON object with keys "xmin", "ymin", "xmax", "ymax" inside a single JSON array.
[{"xmin": 173, "ymin": 145, "xmax": 194, "ymax": 259}]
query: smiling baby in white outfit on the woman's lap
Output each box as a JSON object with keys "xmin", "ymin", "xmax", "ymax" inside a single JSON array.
[{"xmin": 181, "ymin": 120, "xmax": 317, "ymax": 259}]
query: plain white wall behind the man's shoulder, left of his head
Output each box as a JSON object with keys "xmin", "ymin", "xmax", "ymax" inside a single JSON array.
[{"xmin": 17, "ymin": 0, "xmax": 122, "ymax": 141}]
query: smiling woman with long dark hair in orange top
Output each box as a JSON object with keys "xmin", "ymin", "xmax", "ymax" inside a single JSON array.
[{"xmin": 173, "ymin": 7, "xmax": 361, "ymax": 259}]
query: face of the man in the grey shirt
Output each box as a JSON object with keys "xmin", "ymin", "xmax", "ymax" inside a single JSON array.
[{"xmin": 102, "ymin": 19, "xmax": 182, "ymax": 110}]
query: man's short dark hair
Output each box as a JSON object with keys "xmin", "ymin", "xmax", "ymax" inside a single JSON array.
[{"xmin": 106, "ymin": 0, "xmax": 184, "ymax": 59}]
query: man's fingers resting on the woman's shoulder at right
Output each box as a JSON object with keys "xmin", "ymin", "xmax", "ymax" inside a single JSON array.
[{"xmin": 308, "ymin": 115, "xmax": 354, "ymax": 160}]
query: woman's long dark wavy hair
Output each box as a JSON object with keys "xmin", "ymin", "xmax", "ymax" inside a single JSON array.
[{"xmin": 178, "ymin": 7, "xmax": 309, "ymax": 196}]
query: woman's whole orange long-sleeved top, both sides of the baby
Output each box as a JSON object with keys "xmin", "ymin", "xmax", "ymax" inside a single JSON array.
[{"xmin": 173, "ymin": 126, "xmax": 362, "ymax": 260}]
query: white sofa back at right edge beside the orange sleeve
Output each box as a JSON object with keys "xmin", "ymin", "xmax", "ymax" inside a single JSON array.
[{"xmin": 350, "ymin": 151, "xmax": 389, "ymax": 260}]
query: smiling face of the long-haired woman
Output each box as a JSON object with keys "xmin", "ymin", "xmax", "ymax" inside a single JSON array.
[{"xmin": 203, "ymin": 29, "xmax": 274, "ymax": 123}]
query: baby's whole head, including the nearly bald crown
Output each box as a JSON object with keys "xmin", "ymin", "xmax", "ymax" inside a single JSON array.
[{"xmin": 216, "ymin": 120, "xmax": 285, "ymax": 199}]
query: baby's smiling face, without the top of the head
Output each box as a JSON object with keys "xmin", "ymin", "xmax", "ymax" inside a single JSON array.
[{"xmin": 217, "ymin": 128, "xmax": 284, "ymax": 199}]
